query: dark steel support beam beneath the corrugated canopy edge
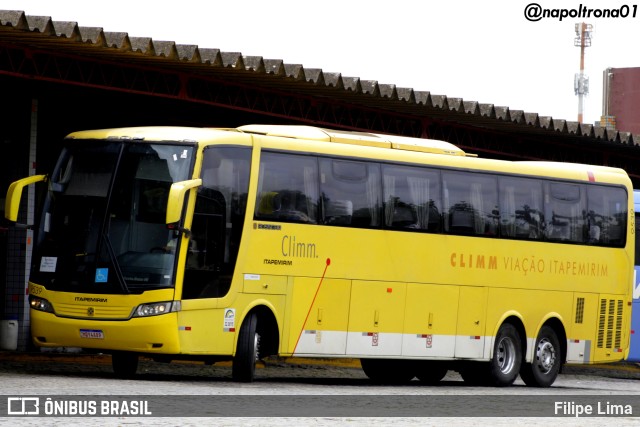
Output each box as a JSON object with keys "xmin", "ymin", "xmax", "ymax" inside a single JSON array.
[{"xmin": 0, "ymin": 44, "xmax": 640, "ymax": 181}]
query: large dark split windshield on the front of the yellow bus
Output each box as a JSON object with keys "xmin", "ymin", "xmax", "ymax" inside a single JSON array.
[{"xmin": 31, "ymin": 141, "xmax": 193, "ymax": 293}]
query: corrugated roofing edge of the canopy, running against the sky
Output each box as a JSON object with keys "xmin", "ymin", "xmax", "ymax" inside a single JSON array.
[{"xmin": 0, "ymin": 10, "xmax": 640, "ymax": 145}]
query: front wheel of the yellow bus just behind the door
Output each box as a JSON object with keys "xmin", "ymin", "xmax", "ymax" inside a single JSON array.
[{"xmin": 231, "ymin": 313, "xmax": 260, "ymax": 382}]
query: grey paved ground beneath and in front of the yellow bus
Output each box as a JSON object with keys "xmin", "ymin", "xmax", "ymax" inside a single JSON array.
[{"xmin": 0, "ymin": 352, "xmax": 640, "ymax": 427}]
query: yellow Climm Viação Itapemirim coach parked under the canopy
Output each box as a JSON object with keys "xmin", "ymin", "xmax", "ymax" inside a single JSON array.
[{"xmin": 6, "ymin": 125, "xmax": 635, "ymax": 387}]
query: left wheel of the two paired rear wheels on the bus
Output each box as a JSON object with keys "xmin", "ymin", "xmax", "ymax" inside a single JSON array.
[{"xmin": 489, "ymin": 323, "xmax": 522, "ymax": 387}]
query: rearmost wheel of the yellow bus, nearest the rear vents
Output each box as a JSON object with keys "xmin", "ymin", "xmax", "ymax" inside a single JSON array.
[{"xmin": 520, "ymin": 326, "xmax": 562, "ymax": 387}]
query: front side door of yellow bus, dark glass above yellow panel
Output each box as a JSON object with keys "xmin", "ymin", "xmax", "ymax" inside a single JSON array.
[{"xmin": 179, "ymin": 146, "xmax": 251, "ymax": 354}]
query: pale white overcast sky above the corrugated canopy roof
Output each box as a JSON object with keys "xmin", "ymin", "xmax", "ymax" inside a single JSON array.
[{"xmin": 0, "ymin": 0, "xmax": 640, "ymax": 123}]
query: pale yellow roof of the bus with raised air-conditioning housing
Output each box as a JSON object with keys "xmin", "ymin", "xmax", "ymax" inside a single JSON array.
[{"xmin": 67, "ymin": 125, "xmax": 630, "ymax": 186}]
